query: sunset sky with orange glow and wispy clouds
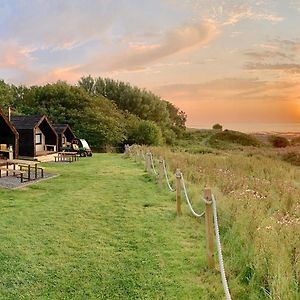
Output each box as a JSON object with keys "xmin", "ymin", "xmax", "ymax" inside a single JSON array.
[{"xmin": 0, "ymin": 0, "xmax": 300, "ymax": 131}]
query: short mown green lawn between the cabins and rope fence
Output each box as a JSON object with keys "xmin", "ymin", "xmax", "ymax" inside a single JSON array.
[{"xmin": 0, "ymin": 154, "xmax": 223, "ymax": 299}]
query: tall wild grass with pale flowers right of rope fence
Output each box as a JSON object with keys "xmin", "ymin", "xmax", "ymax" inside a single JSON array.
[{"xmin": 135, "ymin": 147, "xmax": 300, "ymax": 300}]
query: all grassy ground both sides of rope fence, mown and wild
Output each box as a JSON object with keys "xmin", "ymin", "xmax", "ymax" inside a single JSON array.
[{"xmin": 0, "ymin": 148, "xmax": 300, "ymax": 300}]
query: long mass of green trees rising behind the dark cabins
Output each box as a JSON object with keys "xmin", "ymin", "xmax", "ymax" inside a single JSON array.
[{"xmin": 0, "ymin": 76, "xmax": 186, "ymax": 148}]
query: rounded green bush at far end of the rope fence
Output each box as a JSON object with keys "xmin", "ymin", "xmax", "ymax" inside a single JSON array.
[{"xmin": 130, "ymin": 120, "xmax": 162, "ymax": 145}]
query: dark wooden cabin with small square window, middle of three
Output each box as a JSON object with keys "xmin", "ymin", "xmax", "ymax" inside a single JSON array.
[{"xmin": 11, "ymin": 115, "xmax": 58, "ymax": 157}]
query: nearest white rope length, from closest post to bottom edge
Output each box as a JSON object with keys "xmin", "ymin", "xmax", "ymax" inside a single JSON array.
[{"xmin": 212, "ymin": 195, "xmax": 231, "ymax": 300}]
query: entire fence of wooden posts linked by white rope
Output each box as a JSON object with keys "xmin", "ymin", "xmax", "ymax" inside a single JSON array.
[{"xmin": 124, "ymin": 145, "xmax": 231, "ymax": 300}]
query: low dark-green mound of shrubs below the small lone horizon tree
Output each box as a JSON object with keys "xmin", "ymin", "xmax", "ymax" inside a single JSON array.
[{"xmin": 208, "ymin": 130, "xmax": 261, "ymax": 149}]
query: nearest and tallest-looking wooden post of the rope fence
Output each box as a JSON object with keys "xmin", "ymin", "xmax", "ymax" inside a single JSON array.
[{"xmin": 204, "ymin": 188, "xmax": 215, "ymax": 269}]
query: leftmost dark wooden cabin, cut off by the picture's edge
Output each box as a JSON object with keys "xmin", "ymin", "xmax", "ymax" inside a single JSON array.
[{"xmin": 0, "ymin": 109, "xmax": 19, "ymax": 158}]
